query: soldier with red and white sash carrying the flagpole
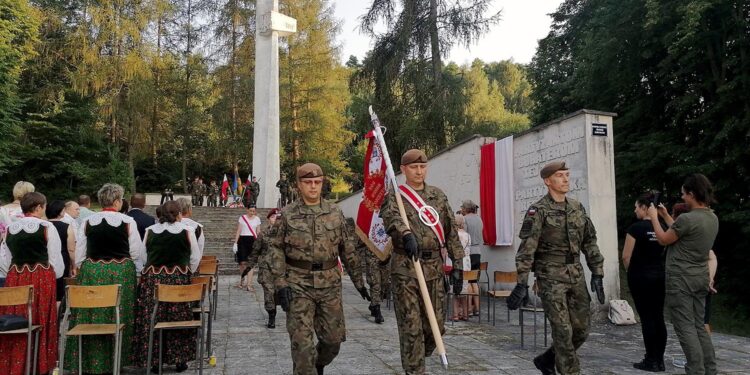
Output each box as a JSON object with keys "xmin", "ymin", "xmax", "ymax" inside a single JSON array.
[{"xmin": 380, "ymin": 149, "xmax": 464, "ymax": 374}]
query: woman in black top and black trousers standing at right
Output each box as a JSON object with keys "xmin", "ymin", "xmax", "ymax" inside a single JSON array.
[{"xmin": 622, "ymin": 193, "xmax": 667, "ymax": 372}]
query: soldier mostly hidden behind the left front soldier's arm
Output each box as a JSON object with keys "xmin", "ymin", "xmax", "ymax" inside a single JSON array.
[{"xmin": 247, "ymin": 208, "xmax": 279, "ymax": 328}]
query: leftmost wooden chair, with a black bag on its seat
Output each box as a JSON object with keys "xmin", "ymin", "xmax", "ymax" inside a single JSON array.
[{"xmin": 0, "ymin": 285, "xmax": 42, "ymax": 375}]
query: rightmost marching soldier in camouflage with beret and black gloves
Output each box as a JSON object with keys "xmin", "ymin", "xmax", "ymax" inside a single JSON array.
[{"xmin": 507, "ymin": 161, "xmax": 604, "ymax": 375}]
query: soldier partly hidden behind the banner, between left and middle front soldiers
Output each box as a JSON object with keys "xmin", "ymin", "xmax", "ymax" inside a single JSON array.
[{"xmin": 346, "ymin": 217, "xmax": 391, "ymax": 324}]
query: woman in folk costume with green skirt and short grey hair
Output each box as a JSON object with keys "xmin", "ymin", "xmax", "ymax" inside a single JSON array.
[{"xmin": 65, "ymin": 184, "xmax": 143, "ymax": 374}]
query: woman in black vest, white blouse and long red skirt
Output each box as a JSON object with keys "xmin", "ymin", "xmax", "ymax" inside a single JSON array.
[{"xmin": 0, "ymin": 192, "xmax": 65, "ymax": 375}]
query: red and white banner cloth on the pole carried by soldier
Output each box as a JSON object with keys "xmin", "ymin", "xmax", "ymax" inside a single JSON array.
[{"xmin": 356, "ymin": 131, "xmax": 391, "ymax": 260}]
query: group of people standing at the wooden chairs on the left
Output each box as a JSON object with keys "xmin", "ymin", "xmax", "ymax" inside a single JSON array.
[{"xmin": 0, "ymin": 181, "xmax": 204, "ymax": 375}]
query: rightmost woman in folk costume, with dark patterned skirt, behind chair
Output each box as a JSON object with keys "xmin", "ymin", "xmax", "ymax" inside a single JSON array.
[{"xmin": 134, "ymin": 201, "xmax": 202, "ymax": 372}]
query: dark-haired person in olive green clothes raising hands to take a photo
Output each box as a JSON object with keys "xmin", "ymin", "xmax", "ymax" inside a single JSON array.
[{"xmin": 648, "ymin": 173, "xmax": 719, "ymax": 374}]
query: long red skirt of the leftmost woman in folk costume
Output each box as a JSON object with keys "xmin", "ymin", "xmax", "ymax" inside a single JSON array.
[{"xmin": 0, "ymin": 264, "xmax": 58, "ymax": 375}]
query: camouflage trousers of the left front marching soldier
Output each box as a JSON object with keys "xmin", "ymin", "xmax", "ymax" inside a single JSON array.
[{"xmin": 286, "ymin": 284, "xmax": 346, "ymax": 375}]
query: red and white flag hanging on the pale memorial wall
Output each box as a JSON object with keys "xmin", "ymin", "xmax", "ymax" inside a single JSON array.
[{"xmin": 479, "ymin": 136, "xmax": 514, "ymax": 246}]
